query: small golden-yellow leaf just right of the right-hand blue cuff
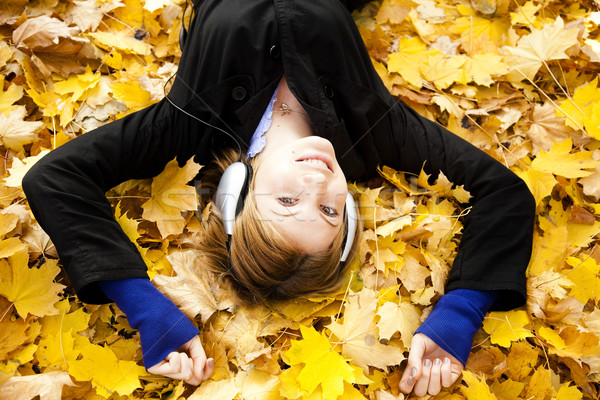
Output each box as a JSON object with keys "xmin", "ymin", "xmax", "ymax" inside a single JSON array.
[{"xmin": 483, "ymin": 310, "xmax": 533, "ymax": 347}]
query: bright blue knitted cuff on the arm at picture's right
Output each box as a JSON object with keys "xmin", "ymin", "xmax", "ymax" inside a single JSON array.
[{"xmin": 415, "ymin": 289, "xmax": 498, "ymax": 365}]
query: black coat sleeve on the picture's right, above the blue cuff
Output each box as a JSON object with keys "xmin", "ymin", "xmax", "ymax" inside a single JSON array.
[{"xmin": 383, "ymin": 102, "xmax": 535, "ymax": 310}]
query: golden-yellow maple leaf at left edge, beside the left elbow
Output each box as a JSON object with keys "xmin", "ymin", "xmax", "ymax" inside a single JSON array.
[{"xmin": 0, "ymin": 251, "xmax": 65, "ymax": 317}]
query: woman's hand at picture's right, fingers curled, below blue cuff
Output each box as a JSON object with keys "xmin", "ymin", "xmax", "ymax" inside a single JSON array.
[{"xmin": 400, "ymin": 333, "xmax": 463, "ymax": 396}]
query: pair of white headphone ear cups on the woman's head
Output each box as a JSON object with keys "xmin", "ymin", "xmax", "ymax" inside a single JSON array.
[{"xmin": 213, "ymin": 161, "xmax": 358, "ymax": 263}]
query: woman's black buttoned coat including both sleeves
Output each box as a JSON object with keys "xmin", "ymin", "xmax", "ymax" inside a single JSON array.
[{"xmin": 23, "ymin": 0, "xmax": 535, "ymax": 309}]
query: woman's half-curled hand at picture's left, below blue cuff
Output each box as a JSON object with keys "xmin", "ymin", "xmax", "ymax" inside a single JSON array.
[{"xmin": 148, "ymin": 336, "xmax": 215, "ymax": 386}]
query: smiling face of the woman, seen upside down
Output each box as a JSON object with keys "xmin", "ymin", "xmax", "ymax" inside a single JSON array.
[{"xmin": 254, "ymin": 136, "xmax": 348, "ymax": 253}]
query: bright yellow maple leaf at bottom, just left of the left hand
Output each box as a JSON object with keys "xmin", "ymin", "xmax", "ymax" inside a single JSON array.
[{"xmin": 69, "ymin": 343, "xmax": 146, "ymax": 397}]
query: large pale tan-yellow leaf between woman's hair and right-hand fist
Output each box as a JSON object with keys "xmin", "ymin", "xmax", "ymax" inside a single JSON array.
[{"xmin": 326, "ymin": 289, "xmax": 412, "ymax": 370}]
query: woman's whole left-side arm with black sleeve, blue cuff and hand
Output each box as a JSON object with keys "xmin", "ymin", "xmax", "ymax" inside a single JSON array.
[{"xmin": 23, "ymin": 101, "xmax": 216, "ymax": 384}]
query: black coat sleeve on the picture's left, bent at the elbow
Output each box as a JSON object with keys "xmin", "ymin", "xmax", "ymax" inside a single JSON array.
[{"xmin": 23, "ymin": 101, "xmax": 209, "ymax": 303}]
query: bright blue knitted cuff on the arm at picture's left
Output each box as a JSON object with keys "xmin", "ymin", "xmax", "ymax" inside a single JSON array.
[{"xmin": 98, "ymin": 278, "xmax": 200, "ymax": 368}]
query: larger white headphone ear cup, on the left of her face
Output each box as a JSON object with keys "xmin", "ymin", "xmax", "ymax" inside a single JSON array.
[{"xmin": 213, "ymin": 161, "xmax": 252, "ymax": 235}]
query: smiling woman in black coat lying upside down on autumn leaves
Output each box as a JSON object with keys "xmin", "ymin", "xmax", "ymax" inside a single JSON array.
[{"xmin": 23, "ymin": 0, "xmax": 534, "ymax": 395}]
